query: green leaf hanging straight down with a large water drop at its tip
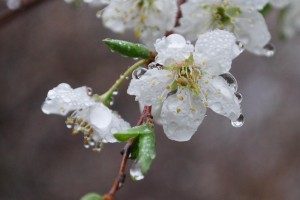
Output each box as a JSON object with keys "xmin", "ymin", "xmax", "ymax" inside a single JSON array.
[{"xmin": 137, "ymin": 134, "xmax": 155, "ymax": 175}]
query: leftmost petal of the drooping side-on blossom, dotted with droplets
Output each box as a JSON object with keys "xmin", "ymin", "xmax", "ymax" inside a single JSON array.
[{"xmin": 42, "ymin": 83, "xmax": 95, "ymax": 115}]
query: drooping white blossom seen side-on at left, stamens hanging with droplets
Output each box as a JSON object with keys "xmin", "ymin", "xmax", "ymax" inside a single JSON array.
[{"xmin": 42, "ymin": 83, "xmax": 130, "ymax": 151}]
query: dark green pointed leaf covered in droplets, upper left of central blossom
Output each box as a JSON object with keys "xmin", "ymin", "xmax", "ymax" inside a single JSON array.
[{"xmin": 103, "ymin": 38, "xmax": 152, "ymax": 59}]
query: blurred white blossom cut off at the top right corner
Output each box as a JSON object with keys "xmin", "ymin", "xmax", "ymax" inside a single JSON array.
[{"xmin": 281, "ymin": 0, "xmax": 300, "ymax": 38}]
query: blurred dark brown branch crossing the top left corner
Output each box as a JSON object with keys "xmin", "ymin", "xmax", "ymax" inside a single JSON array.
[{"xmin": 0, "ymin": 0, "xmax": 53, "ymax": 27}]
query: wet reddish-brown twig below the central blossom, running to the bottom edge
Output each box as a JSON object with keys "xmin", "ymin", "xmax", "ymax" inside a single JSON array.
[{"xmin": 103, "ymin": 106, "xmax": 153, "ymax": 200}]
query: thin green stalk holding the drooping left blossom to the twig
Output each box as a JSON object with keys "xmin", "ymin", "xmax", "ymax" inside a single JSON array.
[{"xmin": 100, "ymin": 59, "xmax": 149, "ymax": 106}]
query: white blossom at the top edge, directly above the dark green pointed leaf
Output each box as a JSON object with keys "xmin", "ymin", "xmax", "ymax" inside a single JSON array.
[{"xmin": 99, "ymin": 0, "xmax": 177, "ymax": 48}]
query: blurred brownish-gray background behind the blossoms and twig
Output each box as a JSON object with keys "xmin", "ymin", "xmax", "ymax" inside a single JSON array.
[{"xmin": 0, "ymin": 0, "xmax": 300, "ymax": 200}]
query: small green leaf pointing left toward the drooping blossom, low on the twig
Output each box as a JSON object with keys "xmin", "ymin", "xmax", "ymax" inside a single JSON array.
[{"xmin": 114, "ymin": 124, "xmax": 154, "ymax": 142}]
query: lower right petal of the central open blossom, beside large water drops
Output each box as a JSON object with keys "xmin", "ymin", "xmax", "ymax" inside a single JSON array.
[{"xmin": 206, "ymin": 76, "xmax": 241, "ymax": 121}]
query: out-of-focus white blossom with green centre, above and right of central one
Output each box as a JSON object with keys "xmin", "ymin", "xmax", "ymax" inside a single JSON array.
[{"xmin": 175, "ymin": 0, "xmax": 271, "ymax": 56}]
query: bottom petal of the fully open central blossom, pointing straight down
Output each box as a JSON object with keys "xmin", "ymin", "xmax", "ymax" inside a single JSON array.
[{"xmin": 161, "ymin": 93, "xmax": 206, "ymax": 141}]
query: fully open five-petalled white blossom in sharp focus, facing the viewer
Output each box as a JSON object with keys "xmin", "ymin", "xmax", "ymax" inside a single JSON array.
[{"xmin": 127, "ymin": 30, "xmax": 243, "ymax": 141}]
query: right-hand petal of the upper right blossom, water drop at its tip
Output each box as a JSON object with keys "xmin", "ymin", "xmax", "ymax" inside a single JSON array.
[{"xmin": 234, "ymin": 10, "xmax": 271, "ymax": 55}]
